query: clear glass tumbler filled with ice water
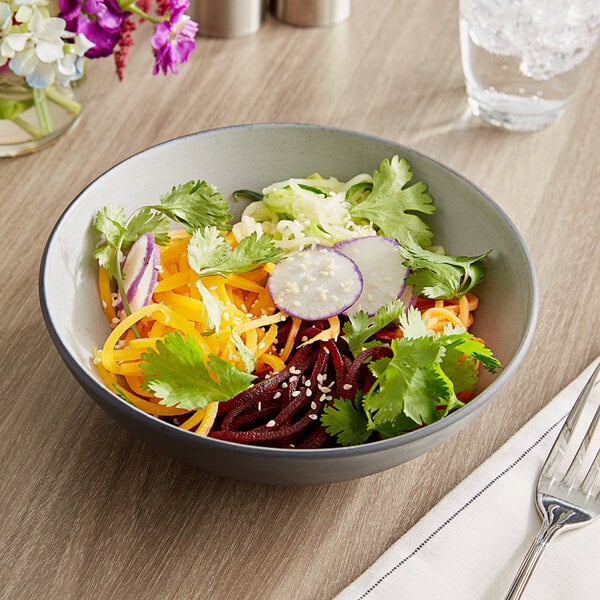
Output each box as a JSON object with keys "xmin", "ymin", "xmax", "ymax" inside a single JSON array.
[{"xmin": 460, "ymin": 0, "xmax": 600, "ymax": 131}]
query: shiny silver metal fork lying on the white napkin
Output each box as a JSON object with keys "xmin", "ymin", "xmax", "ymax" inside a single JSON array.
[{"xmin": 504, "ymin": 363, "xmax": 600, "ymax": 600}]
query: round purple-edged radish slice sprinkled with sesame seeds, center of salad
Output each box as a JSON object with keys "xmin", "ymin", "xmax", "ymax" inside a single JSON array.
[{"xmin": 268, "ymin": 246, "xmax": 362, "ymax": 321}]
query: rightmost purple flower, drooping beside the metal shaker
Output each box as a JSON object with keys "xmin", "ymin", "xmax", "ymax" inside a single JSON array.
[{"xmin": 151, "ymin": 0, "xmax": 198, "ymax": 75}]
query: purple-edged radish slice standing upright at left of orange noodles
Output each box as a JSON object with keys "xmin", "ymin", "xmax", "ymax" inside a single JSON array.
[{"xmin": 123, "ymin": 233, "xmax": 160, "ymax": 312}]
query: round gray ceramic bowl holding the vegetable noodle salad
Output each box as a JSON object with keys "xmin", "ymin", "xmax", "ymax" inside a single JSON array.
[{"xmin": 39, "ymin": 124, "xmax": 538, "ymax": 485}]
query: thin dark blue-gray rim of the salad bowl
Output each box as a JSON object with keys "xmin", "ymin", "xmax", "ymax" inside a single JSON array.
[{"xmin": 38, "ymin": 123, "xmax": 539, "ymax": 460}]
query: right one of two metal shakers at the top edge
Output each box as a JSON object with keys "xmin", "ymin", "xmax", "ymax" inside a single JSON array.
[{"xmin": 271, "ymin": 0, "xmax": 352, "ymax": 27}]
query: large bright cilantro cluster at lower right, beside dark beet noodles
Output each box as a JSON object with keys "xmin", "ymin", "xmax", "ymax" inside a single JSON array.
[{"xmin": 321, "ymin": 307, "xmax": 501, "ymax": 445}]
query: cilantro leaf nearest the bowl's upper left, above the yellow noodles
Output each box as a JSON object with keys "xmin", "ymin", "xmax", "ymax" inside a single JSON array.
[{"xmin": 152, "ymin": 181, "xmax": 232, "ymax": 233}]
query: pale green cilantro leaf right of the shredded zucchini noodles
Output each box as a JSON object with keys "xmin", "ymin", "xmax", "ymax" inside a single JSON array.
[{"xmin": 350, "ymin": 156, "xmax": 435, "ymax": 246}]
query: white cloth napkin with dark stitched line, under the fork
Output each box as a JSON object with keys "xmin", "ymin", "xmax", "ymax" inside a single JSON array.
[{"xmin": 336, "ymin": 361, "xmax": 600, "ymax": 600}]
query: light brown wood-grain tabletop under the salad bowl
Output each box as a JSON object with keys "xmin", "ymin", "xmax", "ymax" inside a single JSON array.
[{"xmin": 0, "ymin": 0, "xmax": 600, "ymax": 600}]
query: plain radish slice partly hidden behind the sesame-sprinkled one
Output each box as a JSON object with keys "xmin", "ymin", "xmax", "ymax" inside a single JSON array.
[{"xmin": 334, "ymin": 235, "xmax": 408, "ymax": 315}]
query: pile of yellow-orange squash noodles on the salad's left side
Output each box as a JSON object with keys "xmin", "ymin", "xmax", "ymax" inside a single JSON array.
[{"xmin": 94, "ymin": 231, "xmax": 292, "ymax": 435}]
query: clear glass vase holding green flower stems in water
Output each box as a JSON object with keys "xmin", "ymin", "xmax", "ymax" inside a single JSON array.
[{"xmin": 0, "ymin": 69, "xmax": 82, "ymax": 158}]
